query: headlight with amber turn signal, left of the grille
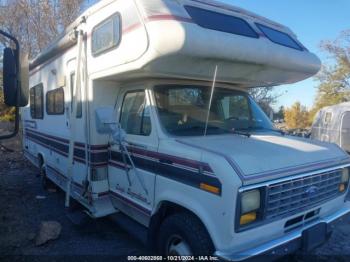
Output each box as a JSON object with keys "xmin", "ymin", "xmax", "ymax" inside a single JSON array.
[{"xmin": 239, "ymin": 189, "xmax": 261, "ymax": 225}]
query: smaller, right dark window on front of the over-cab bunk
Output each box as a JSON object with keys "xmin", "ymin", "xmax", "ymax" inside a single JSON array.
[{"xmin": 256, "ymin": 24, "xmax": 303, "ymax": 51}]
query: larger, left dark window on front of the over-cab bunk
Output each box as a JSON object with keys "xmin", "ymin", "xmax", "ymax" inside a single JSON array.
[{"xmin": 185, "ymin": 6, "xmax": 259, "ymax": 38}]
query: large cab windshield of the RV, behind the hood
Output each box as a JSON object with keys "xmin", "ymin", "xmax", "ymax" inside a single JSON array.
[{"xmin": 154, "ymin": 85, "xmax": 273, "ymax": 136}]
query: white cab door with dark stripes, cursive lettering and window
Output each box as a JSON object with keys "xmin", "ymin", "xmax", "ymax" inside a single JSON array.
[{"xmin": 108, "ymin": 88, "xmax": 158, "ymax": 224}]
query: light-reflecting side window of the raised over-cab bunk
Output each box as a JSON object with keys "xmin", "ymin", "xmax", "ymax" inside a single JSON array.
[{"xmin": 91, "ymin": 14, "xmax": 121, "ymax": 56}]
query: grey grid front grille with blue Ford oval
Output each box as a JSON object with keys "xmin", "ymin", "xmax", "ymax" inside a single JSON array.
[{"xmin": 265, "ymin": 170, "xmax": 342, "ymax": 219}]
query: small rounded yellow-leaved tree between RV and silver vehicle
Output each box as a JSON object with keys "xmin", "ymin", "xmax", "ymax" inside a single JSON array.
[{"xmin": 284, "ymin": 102, "xmax": 309, "ymax": 129}]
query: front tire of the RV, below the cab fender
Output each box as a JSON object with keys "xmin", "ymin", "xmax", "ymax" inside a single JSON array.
[{"xmin": 157, "ymin": 212, "xmax": 214, "ymax": 256}]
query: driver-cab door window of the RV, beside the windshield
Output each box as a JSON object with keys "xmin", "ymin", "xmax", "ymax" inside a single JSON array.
[{"xmin": 120, "ymin": 91, "xmax": 152, "ymax": 136}]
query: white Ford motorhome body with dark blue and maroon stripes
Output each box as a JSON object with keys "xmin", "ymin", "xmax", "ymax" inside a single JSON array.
[{"xmin": 22, "ymin": 0, "xmax": 350, "ymax": 260}]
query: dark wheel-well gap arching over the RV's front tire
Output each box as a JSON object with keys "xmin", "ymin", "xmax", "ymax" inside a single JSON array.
[{"xmin": 147, "ymin": 201, "xmax": 210, "ymax": 249}]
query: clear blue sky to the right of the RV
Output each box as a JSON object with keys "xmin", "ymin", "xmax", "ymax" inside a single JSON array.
[{"xmin": 220, "ymin": 0, "xmax": 350, "ymax": 108}]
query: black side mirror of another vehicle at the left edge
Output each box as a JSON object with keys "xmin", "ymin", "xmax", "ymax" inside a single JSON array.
[{"xmin": 3, "ymin": 47, "xmax": 29, "ymax": 107}]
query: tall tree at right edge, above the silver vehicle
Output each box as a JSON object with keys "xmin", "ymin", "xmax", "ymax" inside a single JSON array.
[{"xmin": 310, "ymin": 29, "xmax": 350, "ymax": 119}]
